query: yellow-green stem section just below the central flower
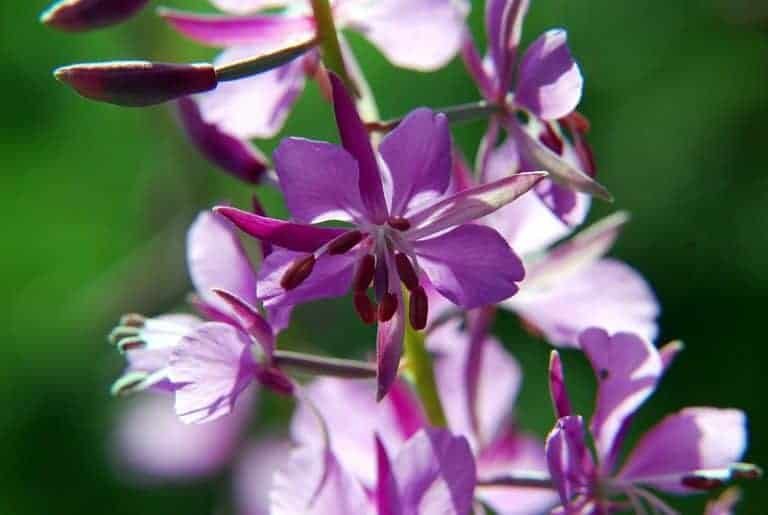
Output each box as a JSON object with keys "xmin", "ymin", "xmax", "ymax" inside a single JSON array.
[{"xmin": 405, "ymin": 314, "xmax": 447, "ymax": 427}]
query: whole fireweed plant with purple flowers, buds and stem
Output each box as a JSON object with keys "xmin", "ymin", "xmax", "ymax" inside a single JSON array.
[{"xmin": 48, "ymin": 0, "xmax": 760, "ymax": 515}]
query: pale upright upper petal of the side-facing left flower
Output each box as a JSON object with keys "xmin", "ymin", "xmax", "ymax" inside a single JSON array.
[{"xmin": 187, "ymin": 211, "xmax": 256, "ymax": 313}]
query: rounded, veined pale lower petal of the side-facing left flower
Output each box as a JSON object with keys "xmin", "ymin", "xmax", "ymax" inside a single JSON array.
[{"xmin": 168, "ymin": 322, "xmax": 257, "ymax": 424}]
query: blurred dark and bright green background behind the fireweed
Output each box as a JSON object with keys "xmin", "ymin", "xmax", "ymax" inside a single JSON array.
[{"xmin": 0, "ymin": 0, "xmax": 768, "ymax": 515}]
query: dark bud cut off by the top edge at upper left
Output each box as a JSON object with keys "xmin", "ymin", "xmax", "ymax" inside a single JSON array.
[{"xmin": 40, "ymin": 0, "xmax": 149, "ymax": 32}]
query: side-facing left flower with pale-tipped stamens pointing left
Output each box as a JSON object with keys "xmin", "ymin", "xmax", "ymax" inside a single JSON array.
[{"xmin": 112, "ymin": 212, "xmax": 293, "ymax": 423}]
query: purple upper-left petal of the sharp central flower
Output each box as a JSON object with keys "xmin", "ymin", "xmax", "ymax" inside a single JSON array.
[{"xmin": 274, "ymin": 138, "xmax": 365, "ymax": 224}]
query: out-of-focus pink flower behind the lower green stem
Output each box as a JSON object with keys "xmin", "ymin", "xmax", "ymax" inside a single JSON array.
[{"xmin": 291, "ymin": 322, "xmax": 557, "ymax": 515}]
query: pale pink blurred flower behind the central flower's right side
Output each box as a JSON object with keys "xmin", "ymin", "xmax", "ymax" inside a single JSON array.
[{"xmin": 456, "ymin": 142, "xmax": 659, "ymax": 346}]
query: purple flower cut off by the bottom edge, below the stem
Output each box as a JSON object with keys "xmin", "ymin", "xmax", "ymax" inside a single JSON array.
[{"xmin": 270, "ymin": 408, "xmax": 476, "ymax": 515}]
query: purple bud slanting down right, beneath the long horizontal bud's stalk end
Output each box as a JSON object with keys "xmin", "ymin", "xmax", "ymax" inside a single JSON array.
[{"xmin": 179, "ymin": 98, "xmax": 267, "ymax": 184}]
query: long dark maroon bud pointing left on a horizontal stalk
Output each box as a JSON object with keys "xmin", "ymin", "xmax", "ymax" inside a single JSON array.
[{"xmin": 54, "ymin": 61, "xmax": 218, "ymax": 107}]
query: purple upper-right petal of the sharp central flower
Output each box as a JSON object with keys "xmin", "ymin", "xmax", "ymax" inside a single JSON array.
[{"xmin": 379, "ymin": 108, "xmax": 451, "ymax": 216}]
